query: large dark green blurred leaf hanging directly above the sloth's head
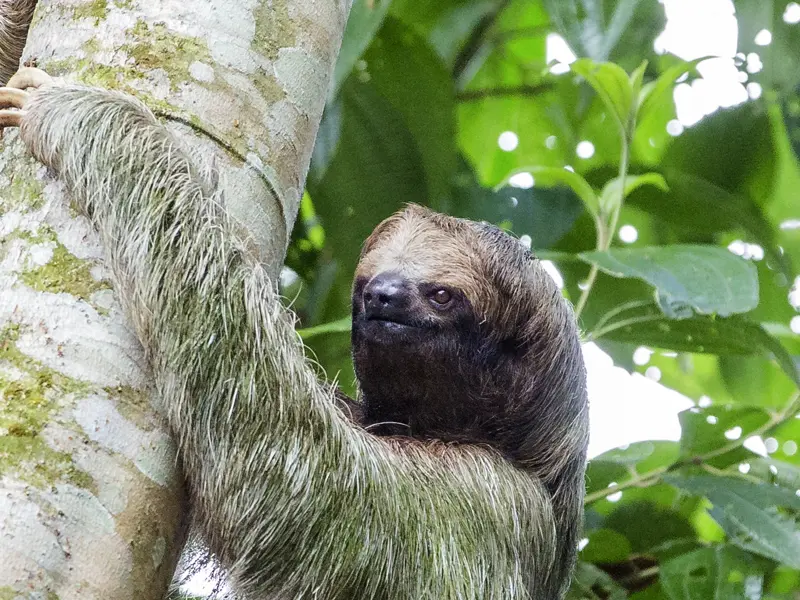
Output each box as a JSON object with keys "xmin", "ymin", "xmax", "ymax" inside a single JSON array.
[{"xmin": 364, "ymin": 18, "xmax": 457, "ymax": 210}]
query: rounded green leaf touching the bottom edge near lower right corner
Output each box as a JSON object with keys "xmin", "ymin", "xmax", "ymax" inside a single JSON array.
[{"xmin": 660, "ymin": 545, "xmax": 764, "ymax": 600}]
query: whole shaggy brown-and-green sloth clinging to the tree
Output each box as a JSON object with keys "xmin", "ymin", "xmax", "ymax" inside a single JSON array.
[{"xmin": 0, "ymin": 69, "xmax": 588, "ymax": 600}]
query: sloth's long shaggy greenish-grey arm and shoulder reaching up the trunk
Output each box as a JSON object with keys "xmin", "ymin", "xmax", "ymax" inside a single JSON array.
[{"xmin": 0, "ymin": 78, "xmax": 558, "ymax": 600}]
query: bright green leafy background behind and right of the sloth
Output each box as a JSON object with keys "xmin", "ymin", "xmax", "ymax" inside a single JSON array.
[{"xmin": 284, "ymin": 0, "xmax": 800, "ymax": 600}]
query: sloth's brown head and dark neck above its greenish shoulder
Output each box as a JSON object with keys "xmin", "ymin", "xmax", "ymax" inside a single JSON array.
[{"xmin": 353, "ymin": 206, "xmax": 587, "ymax": 479}]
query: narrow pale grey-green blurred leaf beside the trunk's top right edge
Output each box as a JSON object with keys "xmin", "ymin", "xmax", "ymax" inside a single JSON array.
[{"xmin": 330, "ymin": 0, "xmax": 392, "ymax": 98}]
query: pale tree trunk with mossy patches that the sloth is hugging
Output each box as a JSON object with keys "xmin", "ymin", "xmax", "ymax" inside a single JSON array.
[{"xmin": 0, "ymin": 0, "xmax": 349, "ymax": 600}]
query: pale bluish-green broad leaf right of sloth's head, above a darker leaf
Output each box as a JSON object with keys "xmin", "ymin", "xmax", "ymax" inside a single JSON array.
[{"xmin": 580, "ymin": 245, "xmax": 758, "ymax": 318}]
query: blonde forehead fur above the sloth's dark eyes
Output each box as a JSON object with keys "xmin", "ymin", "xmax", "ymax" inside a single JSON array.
[{"xmin": 356, "ymin": 205, "xmax": 527, "ymax": 316}]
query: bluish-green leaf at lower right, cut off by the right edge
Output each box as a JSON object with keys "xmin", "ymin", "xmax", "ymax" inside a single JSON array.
[{"xmin": 664, "ymin": 475, "xmax": 800, "ymax": 568}]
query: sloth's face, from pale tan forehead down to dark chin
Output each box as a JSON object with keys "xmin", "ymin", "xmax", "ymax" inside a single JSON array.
[{"xmin": 352, "ymin": 213, "xmax": 492, "ymax": 355}]
